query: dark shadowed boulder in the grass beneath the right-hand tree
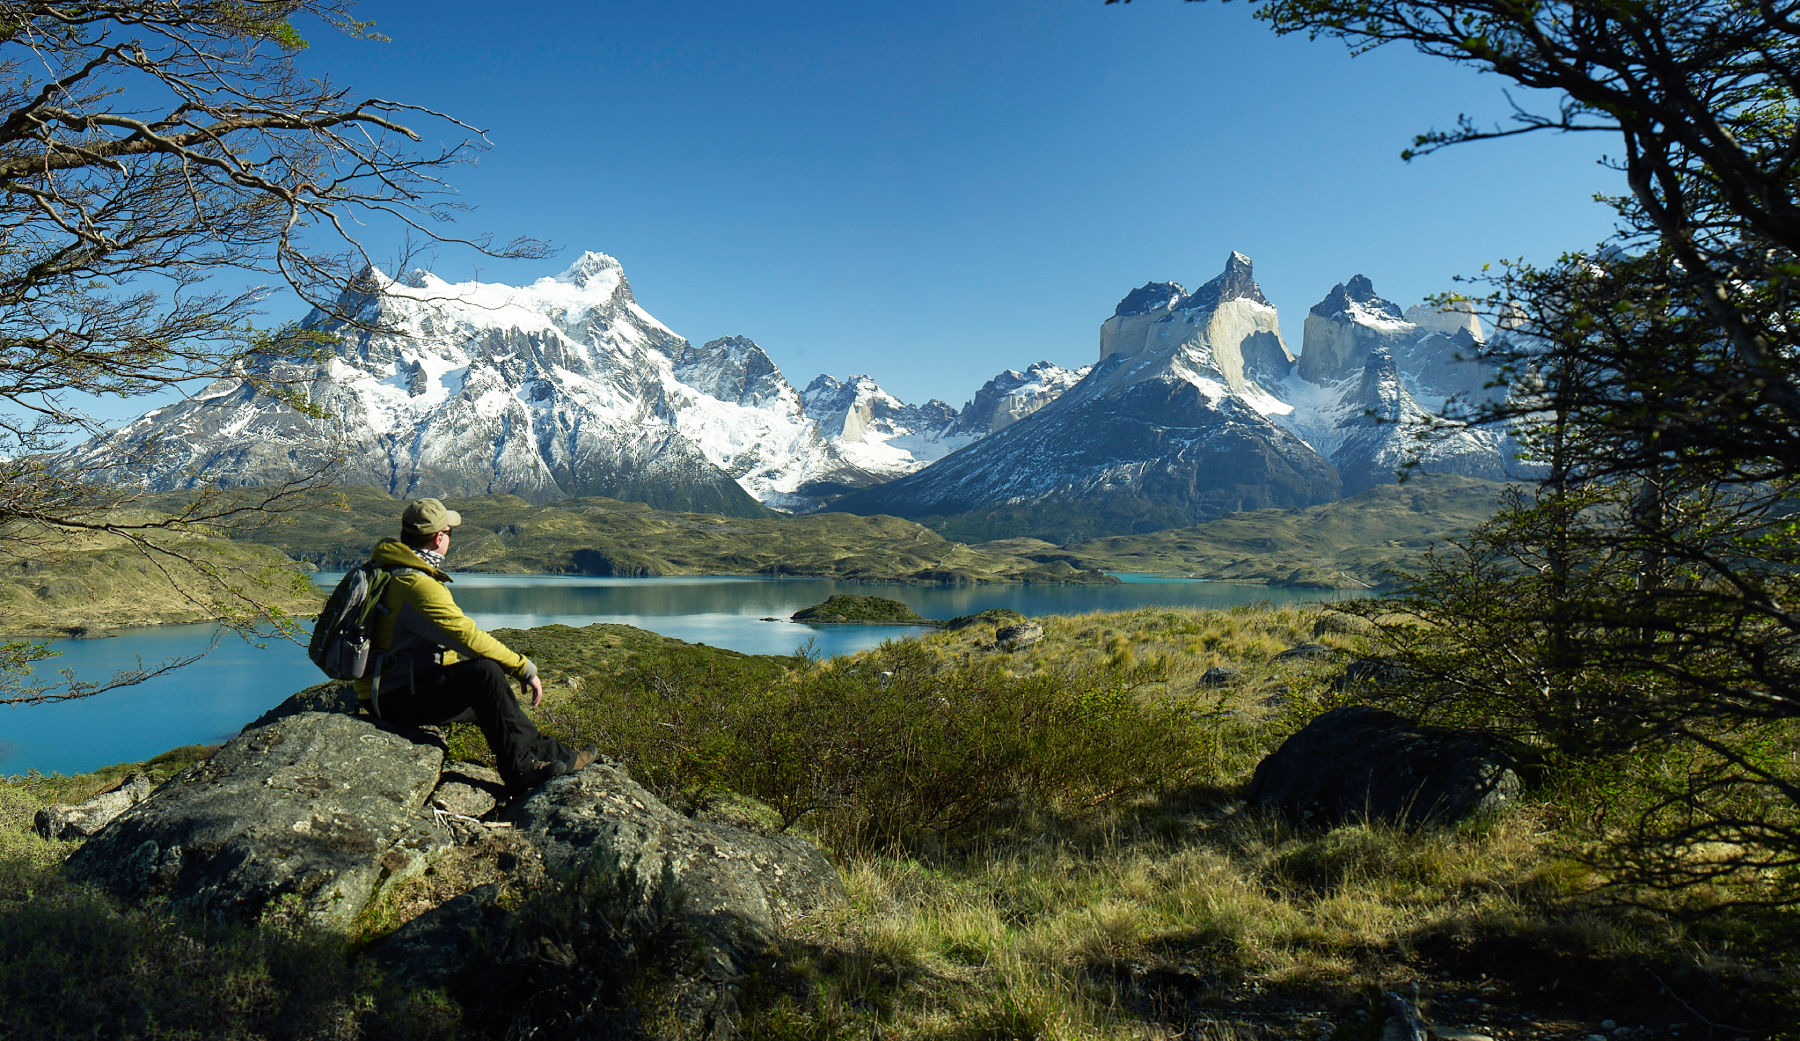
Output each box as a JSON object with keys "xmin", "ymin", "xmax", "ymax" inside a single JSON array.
[{"xmin": 1246, "ymin": 704, "xmax": 1521, "ymax": 825}]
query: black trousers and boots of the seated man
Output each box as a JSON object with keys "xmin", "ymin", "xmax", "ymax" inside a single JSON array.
[{"xmin": 378, "ymin": 657, "xmax": 574, "ymax": 794}]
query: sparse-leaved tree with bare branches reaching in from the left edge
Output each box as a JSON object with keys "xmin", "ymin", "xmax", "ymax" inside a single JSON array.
[{"xmin": 0, "ymin": 0, "xmax": 542, "ymax": 702}]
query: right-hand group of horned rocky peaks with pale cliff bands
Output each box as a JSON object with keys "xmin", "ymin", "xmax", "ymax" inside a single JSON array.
[{"xmin": 832, "ymin": 252, "xmax": 1530, "ymax": 542}]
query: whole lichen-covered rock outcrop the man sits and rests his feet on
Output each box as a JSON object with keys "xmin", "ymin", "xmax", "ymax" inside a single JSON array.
[{"xmin": 51, "ymin": 684, "xmax": 846, "ymax": 1037}]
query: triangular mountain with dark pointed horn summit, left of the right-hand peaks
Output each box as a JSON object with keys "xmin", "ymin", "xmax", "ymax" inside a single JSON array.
[{"xmin": 832, "ymin": 254, "xmax": 1341, "ymax": 537}]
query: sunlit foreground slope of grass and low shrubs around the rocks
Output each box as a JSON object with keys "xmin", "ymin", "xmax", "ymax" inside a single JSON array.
[{"xmin": 0, "ymin": 607, "xmax": 1800, "ymax": 1041}]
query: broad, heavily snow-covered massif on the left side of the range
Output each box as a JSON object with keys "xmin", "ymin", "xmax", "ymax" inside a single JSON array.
[{"xmin": 74, "ymin": 252, "xmax": 781, "ymax": 513}]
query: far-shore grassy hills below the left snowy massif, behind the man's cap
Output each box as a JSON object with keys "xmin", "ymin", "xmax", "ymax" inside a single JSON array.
[{"xmin": 207, "ymin": 488, "xmax": 1111, "ymax": 582}]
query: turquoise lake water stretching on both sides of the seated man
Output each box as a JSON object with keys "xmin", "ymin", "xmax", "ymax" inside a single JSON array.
[{"xmin": 0, "ymin": 573, "xmax": 1345, "ymax": 773}]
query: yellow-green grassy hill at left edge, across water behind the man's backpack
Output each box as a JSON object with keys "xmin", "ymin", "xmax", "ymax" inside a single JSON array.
[{"xmin": 0, "ymin": 531, "xmax": 324, "ymax": 636}]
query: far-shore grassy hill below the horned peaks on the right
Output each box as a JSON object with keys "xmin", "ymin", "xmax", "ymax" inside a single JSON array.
[{"xmin": 1029, "ymin": 474, "xmax": 1505, "ymax": 589}]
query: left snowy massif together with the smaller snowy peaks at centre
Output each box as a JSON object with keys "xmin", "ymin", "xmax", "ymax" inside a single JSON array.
[{"xmin": 72, "ymin": 252, "xmax": 1073, "ymax": 513}]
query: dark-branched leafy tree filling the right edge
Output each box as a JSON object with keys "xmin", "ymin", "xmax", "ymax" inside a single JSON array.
[{"xmin": 1109, "ymin": 0, "xmax": 1800, "ymax": 902}]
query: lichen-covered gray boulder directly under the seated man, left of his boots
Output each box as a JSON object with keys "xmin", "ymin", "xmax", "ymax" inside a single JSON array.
[{"xmin": 65, "ymin": 713, "xmax": 448, "ymax": 929}]
